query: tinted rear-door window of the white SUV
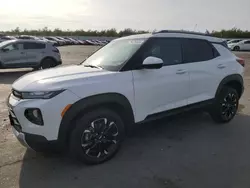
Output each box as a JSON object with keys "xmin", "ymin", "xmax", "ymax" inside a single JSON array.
[{"xmin": 182, "ymin": 39, "xmax": 214, "ymax": 63}]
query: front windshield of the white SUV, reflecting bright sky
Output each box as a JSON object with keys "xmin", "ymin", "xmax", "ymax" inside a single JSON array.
[{"xmin": 83, "ymin": 39, "xmax": 145, "ymax": 71}]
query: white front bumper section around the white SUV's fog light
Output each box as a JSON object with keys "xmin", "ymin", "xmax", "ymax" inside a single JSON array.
[{"xmin": 7, "ymin": 90, "xmax": 79, "ymax": 141}]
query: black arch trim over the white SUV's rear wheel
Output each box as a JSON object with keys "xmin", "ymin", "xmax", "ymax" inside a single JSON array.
[{"xmin": 215, "ymin": 74, "xmax": 244, "ymax": 97}]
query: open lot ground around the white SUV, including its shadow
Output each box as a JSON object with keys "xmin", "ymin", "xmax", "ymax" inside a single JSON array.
[{"xmin": 0, "ymin": 46, "xmax": 250, "ymax": 188}]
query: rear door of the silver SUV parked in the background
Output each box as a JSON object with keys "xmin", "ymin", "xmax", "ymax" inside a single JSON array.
[{"xmin": 23, "ymin": 42, "xmax": 46, "ymax": 66}]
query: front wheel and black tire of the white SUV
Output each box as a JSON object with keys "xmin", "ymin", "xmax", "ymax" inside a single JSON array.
[{"xmin": 70, "ymin": 108, "xmax": 125, "ymax": 164}]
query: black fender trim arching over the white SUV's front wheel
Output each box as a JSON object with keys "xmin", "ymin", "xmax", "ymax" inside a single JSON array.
[{"xmin": 58, "ymin": 93, "xmax": 134, "ymax": 145}]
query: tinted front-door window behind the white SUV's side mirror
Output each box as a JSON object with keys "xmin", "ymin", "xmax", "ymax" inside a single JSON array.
[{"xmin": 142, "ymin": 38, "xmax": 182, "ymax": 65}]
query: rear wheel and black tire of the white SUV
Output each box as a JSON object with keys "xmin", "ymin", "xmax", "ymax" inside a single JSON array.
[{"xmin": 210, "ymin": 87, "xmax": 239, "ymax": 123}]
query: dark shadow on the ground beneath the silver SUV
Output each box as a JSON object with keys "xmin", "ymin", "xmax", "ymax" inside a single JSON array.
[{"xmin": 0, "ymin": 69, "xmax": 32, "ymax": 84}]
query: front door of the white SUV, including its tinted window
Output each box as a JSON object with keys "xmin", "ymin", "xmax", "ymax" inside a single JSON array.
[{"xmin": 132, "ymin": 38, "xmax": 189, "ymax": 121}]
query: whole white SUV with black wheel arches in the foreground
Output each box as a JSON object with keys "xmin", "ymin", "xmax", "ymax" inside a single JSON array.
[{"xmin": 8, "ymin": 31, "xmax": 244, "ymax": 164}]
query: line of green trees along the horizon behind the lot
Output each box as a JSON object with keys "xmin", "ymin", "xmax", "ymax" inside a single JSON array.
[{"xmin": 0, "ymin": 27, "xmax": 250, "ymax": 38}]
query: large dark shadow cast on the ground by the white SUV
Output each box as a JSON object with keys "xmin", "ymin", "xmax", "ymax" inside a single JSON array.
[{"xmin": 19, "ymin": 113, "xmax": 250, "ymax": 188}]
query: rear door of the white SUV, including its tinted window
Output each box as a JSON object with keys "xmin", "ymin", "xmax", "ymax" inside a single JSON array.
[{"xmin": 182, "ymin": 39, "xmax": 227, "ymax": 104}]
